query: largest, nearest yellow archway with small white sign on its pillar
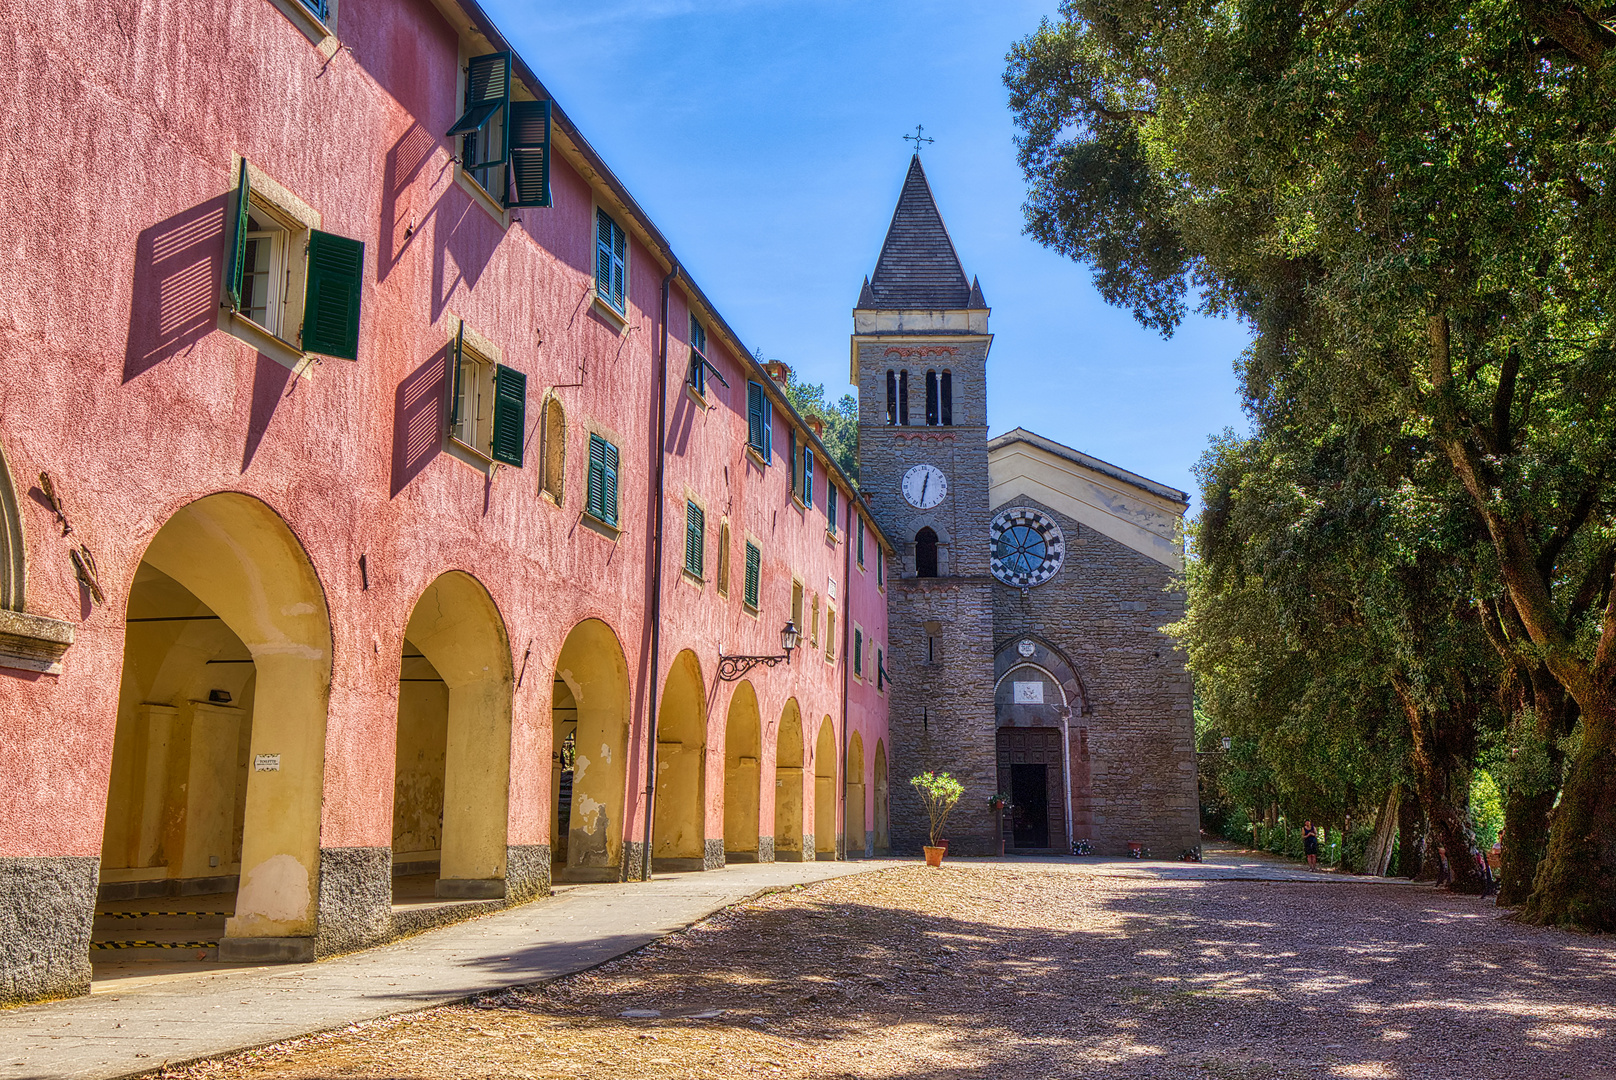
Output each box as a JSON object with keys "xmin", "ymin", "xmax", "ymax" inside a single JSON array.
[{"xmin": 92, "ymin": 493, "xmax": 331, "ymax": 959}]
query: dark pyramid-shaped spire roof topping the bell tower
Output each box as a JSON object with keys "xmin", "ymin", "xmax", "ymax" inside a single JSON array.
[{"xmin": 858, "ymin": 154, "xmax": 986, "ymax": 310}]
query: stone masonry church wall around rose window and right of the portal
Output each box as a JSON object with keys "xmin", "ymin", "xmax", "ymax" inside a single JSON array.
[{"xmin": 992, "ymin": 498, "xmax": 1199, "ymax": 859}]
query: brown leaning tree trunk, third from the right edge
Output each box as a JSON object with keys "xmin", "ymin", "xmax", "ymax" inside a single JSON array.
[{"xmin": 1396, "ymin": 686, "xmax": 1483, "ymax": 894}]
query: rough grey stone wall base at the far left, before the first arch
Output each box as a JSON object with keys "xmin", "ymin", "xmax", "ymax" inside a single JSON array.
[{"xmin": 0, "ymin": 855, "xmax": 100, "ymax": 1006}]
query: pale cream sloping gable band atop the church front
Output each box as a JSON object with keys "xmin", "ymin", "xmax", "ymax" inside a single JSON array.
[{"xmin": 987, "ymin": 428, "xmax": 1188, "ymax": 571}]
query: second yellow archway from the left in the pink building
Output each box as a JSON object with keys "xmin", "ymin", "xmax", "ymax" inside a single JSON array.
[{"xmin": 393, "ymin": 571, "xmax": 514, "ymax": 899}]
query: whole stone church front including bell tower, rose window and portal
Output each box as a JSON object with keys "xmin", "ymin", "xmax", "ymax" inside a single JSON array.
[{"xmin": 852, "ymin": 155, "xmax": 1199, "ymax": 857}]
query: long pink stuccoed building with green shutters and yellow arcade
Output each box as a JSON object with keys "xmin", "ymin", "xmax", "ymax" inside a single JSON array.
[{"xmin": 0, "ymin": 0, "xmax": 892, "ymax": 1002}]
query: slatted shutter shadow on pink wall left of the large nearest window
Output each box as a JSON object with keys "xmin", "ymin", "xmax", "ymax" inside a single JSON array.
[{"xmin": 123, "ymin": 194, "xmax": 229, "ymax": 383}]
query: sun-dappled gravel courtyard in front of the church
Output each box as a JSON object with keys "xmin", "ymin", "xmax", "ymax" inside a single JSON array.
[{"xmin": 162, "ymin": 863, "xmax": 1616, "ymax": 1080}]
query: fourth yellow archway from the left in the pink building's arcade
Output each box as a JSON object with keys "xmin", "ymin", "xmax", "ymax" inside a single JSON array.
[{"xmin": 651, "ymin": 648, "xmax": 706, "ymax": 871}]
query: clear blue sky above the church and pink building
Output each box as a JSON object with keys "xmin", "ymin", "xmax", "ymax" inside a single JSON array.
[{"xmin": 485, "ymin": 0, "xmax": 1246, "ymax": 491}]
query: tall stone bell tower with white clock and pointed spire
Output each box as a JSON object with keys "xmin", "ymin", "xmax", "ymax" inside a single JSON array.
[{"xmin": 852, "ymin": 154, "xmax": 999, "ymax": 855}]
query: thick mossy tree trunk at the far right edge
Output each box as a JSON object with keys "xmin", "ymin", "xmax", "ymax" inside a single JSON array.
[{"xmin": 1522, "ymin": 687, "xmax": 1616, "ymax": 933}]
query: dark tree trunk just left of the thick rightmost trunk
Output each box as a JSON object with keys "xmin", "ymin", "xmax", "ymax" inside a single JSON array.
[{"xmin": 1498, "ymin": 664, "xmax": 1576, "ymax": 907}]
